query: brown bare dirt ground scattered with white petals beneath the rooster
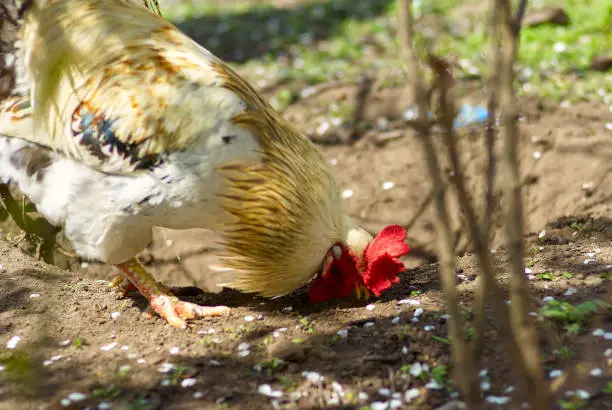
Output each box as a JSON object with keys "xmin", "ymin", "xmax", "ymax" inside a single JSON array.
[{"xmin": 0, "ymin": 87, "xmax": 612, "ymax": 409}]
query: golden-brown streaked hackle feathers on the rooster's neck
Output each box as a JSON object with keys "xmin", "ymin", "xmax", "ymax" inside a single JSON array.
[{"xmin": 212, "ymin": 63, "xmax": 346, "ymax": 297}]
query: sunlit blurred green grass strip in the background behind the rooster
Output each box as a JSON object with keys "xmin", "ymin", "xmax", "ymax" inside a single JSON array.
[{"xmin": 162, "ymin": 0, "xmax": 612, "ymax": 108}]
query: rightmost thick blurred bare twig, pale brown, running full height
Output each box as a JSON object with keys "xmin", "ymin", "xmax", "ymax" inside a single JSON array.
[{"xmin": 494, "ymin": 0, "xmax": 551, "ymax": 409}]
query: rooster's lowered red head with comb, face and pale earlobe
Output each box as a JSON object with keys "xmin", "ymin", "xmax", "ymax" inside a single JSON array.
[{"xmin": 308, "ymin": 225, "xmax": 410, "ymax": 302}]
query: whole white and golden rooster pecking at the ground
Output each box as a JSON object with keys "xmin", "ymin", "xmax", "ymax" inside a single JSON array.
[{"xmin": 0, "ymin": 0, "xmax": 409, "ymax": 328}]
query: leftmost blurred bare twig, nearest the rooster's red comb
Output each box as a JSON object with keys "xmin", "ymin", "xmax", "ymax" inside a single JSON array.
[{"xmin": 398, "ymin": 0, "xmax": 482, "ymax": 409}]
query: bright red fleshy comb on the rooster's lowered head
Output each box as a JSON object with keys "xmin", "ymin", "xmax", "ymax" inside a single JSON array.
[{"xmin": 363, "ymin": 225, "xmax": 410, "ymax": 296}]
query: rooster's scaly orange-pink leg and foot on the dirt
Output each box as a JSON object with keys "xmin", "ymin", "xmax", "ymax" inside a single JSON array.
[{"xmin": 117, "ymin": 258, "xmax": 230, "ymax": 328}]
